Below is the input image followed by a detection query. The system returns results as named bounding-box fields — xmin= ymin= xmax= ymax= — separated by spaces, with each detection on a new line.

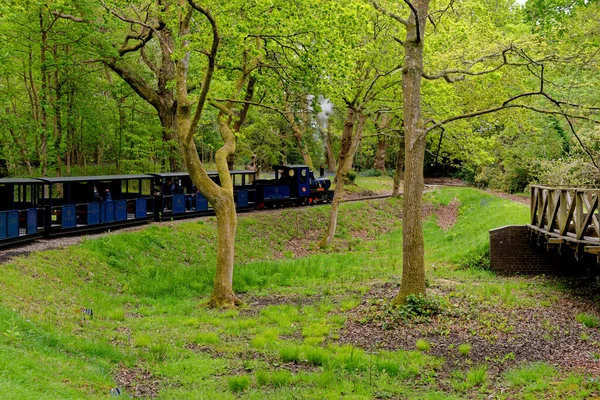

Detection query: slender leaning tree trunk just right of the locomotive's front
xmin=319 ymin=108 xmax=367 ymax=248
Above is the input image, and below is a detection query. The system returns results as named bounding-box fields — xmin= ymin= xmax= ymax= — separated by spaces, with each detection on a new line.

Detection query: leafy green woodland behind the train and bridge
xmin=0 ymin=0 xmax=600 ymax=192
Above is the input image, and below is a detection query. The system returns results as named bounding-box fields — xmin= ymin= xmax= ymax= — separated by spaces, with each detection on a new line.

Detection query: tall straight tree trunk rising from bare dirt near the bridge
xmin=394 ymin=0 xmax=429 ymax=304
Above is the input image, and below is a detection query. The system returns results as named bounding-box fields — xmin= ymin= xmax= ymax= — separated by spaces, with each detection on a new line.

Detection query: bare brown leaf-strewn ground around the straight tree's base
xmin=340 ymin=279 xmax=600 ymax=375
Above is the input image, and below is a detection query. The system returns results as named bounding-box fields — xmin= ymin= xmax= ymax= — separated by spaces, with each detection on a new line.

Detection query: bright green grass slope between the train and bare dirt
xmin=0 ymin=186 xmax=592 ymax=399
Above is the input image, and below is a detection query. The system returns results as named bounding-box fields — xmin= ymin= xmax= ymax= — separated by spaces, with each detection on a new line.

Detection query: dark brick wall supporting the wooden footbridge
xmin=489 ymin=225 xmax=595 ymax=275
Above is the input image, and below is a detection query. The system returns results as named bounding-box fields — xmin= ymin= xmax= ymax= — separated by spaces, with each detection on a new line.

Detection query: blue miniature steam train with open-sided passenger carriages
xmin=0 ymin=165 xmax=333 ymax=247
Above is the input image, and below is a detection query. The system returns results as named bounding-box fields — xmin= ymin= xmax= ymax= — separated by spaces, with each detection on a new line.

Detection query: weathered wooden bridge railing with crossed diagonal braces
xmin=528 ymin=185 xmax=600 ymax=247
